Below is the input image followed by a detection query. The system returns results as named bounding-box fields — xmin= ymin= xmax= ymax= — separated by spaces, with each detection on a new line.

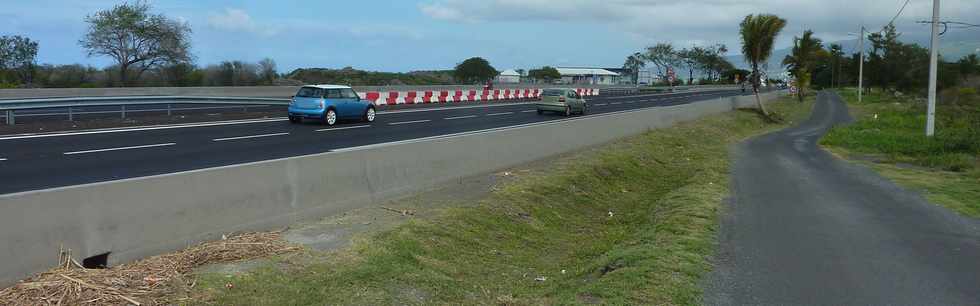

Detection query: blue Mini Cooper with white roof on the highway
xmin=289 ymin=85 xmax=376 ymax=125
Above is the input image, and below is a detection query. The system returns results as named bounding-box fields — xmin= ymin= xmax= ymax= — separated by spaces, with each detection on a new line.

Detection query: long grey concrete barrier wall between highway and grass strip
xmin=0 ymin=93 xmax=777 ymax=285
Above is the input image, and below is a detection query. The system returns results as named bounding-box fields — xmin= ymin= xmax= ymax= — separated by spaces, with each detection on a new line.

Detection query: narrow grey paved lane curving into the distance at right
xmin=705 ymin=92 xmax=980 ymax=305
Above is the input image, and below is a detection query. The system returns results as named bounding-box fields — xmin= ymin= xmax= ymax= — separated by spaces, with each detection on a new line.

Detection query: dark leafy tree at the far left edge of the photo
xmin=0 ymin=35 xmax=38 ymax=84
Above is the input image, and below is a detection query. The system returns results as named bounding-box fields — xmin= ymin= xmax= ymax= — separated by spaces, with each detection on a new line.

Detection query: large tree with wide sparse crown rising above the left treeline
xmin=78 ymin=2 xmax=191 ymax=86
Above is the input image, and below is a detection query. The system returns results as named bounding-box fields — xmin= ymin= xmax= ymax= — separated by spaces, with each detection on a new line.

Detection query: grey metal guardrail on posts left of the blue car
xmin=0 ymin=96 xmax=289 ymax=125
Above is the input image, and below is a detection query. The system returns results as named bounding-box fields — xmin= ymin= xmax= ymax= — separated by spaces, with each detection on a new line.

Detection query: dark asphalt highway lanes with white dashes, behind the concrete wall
xmin=0 ymin=90 xmax=742 ymax=194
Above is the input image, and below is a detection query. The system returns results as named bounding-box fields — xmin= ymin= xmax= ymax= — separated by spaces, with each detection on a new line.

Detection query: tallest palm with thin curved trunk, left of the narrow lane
xmin=739 ymin=14 xmax=786 ymax=116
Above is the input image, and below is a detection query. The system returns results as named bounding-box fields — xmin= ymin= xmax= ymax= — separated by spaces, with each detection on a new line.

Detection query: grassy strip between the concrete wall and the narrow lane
xmin=193 ymin=94 xmax=810 ymax=305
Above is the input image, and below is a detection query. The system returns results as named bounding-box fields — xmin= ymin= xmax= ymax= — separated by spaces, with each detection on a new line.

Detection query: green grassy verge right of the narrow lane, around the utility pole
xmin=821 ymin=89 xmax=980 ymax=218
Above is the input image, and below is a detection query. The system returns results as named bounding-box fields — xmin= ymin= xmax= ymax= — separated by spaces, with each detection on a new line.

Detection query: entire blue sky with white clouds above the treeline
xmin=0 ymin=0 xmax=980 ymax=71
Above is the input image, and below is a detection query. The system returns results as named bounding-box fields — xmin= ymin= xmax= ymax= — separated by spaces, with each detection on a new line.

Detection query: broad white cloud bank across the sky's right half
xmin=419 ymin=0 xmax=980 ymax=50
